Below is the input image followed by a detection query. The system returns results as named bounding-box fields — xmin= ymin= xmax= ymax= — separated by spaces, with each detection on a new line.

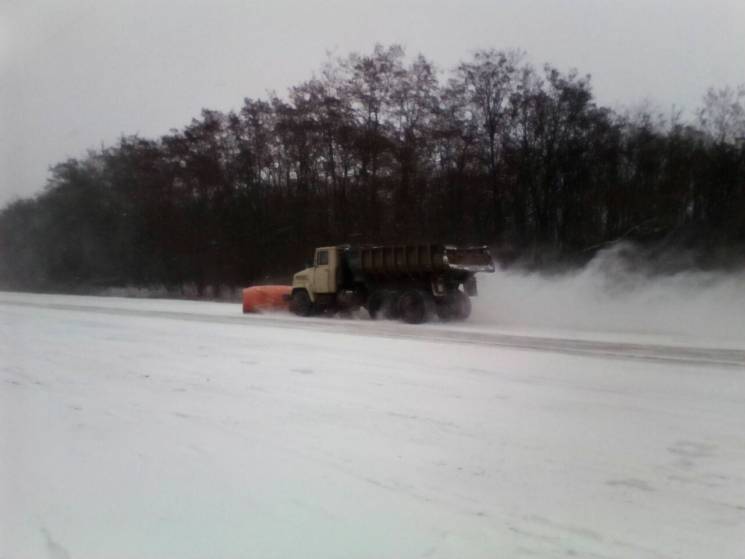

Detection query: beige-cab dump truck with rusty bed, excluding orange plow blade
xmin=289 ymin=244 xmax=494 ymax=324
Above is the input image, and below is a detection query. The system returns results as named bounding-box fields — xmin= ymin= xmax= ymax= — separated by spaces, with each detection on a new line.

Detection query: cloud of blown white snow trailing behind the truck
xmin=472 ymin=244 xmax=745 ymax=342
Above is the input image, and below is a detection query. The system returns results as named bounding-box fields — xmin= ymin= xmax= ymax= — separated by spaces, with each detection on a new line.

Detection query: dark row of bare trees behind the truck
xmin=0 ymin=45 xmax=745 ymax=292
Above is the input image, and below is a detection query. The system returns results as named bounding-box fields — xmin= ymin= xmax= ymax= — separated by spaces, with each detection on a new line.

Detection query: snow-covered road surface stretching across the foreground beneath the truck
xmin=0 ymin=294 xmax=745 ymax=559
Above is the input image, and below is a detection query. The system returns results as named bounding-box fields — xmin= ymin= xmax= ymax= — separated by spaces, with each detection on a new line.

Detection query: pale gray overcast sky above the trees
xmin=0 ymin=0 xmax=745 ymax=206
